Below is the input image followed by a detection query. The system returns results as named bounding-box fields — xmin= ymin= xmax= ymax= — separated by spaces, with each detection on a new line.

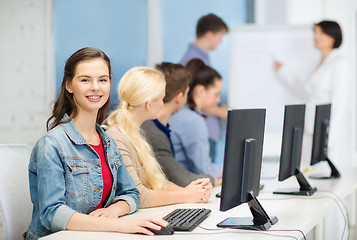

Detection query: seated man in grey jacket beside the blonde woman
xmin=141 ymin=62 xmax=221 ymax=187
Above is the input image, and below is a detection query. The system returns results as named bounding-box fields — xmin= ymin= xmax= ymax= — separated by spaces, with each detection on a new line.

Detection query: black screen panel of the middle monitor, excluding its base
xmin=279 ymin=105 xmax=305 ymax=181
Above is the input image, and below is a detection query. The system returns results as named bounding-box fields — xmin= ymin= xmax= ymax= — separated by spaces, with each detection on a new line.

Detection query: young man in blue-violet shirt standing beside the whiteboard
xmin=180 ymin=13 xmax=228 ymax=161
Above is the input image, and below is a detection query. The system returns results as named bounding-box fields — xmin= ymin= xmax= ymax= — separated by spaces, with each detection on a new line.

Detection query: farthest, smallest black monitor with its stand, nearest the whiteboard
xmin=309 ymin=104 xmax=341 ymax=179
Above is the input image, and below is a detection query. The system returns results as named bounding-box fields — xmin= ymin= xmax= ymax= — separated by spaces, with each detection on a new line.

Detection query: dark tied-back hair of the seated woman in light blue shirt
xmin=186 ymin=58 xmax=222 ymax=110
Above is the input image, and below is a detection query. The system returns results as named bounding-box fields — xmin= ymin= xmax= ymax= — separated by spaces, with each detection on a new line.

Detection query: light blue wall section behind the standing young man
xmin=161 ymin=0 xmax=247 ymax=102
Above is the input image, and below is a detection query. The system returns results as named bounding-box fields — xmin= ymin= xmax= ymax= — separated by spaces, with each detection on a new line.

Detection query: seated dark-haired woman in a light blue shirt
xmin=169 ymin=59 xmax=222 ymax=178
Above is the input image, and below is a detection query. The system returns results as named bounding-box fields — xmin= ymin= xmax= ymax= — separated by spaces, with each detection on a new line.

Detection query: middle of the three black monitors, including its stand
xmin=274 ymin=105 xmax=316 ymax=196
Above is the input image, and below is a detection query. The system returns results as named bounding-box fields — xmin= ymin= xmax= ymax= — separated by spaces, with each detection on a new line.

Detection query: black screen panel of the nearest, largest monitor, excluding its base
xmin=220 ymin=109 xmax=266 ymax=211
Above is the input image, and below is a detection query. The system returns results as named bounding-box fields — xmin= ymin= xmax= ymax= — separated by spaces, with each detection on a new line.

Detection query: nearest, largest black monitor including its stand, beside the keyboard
xmin=217 ymin=109 xmax=278 ymax=230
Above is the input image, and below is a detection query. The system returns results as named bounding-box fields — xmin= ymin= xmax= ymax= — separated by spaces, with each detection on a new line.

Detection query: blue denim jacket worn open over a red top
xmin=26 ymin=115 xmax=140 ymax=239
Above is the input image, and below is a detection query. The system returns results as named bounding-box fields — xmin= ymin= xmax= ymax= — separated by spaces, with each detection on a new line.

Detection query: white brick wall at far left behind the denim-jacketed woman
xmin=0 ymin=0 xmax=55 ymax=145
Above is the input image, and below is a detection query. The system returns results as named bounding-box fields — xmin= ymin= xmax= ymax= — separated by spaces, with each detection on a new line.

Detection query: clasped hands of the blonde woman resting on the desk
xmin=185 ymin=178 xmax=212 ymax=202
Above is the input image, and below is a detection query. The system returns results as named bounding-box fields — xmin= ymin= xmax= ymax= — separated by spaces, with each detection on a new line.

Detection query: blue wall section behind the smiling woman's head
xmin=54 ymin=0 xmax=147 ymax=108
